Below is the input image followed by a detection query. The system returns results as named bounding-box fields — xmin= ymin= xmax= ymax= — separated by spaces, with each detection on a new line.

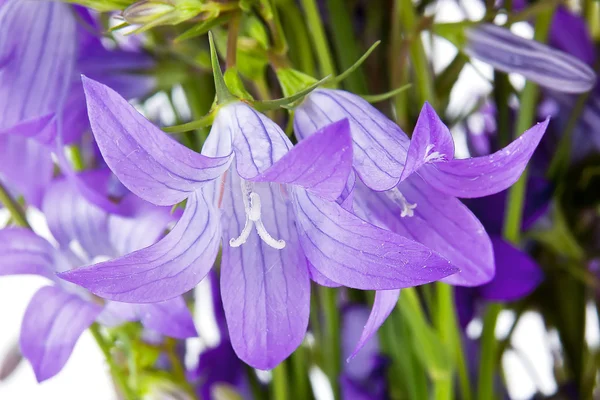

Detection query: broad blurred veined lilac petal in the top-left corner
xmin=0 ymin=0 xmax=76 ymax=141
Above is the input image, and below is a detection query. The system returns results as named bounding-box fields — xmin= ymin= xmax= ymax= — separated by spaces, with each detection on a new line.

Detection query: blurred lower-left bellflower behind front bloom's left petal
xmin=0 ymin=173 xmax=197 ymax=382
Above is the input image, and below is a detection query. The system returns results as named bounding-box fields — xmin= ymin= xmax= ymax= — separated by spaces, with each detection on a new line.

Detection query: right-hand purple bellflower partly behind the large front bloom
xmin=294 ymin=89 xmax=548 ymax=350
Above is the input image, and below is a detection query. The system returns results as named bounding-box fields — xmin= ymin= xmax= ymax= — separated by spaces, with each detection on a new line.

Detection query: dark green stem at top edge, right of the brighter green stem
xmin=327 ymin=0 xmax=368 ymax=93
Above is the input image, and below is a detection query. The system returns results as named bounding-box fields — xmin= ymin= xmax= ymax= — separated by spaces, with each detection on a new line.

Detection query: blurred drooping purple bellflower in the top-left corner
xmin=0 ymin=0 xmax=154 ymax=211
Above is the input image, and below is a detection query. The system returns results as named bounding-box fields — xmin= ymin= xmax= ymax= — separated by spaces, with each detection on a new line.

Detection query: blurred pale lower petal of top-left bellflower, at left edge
xmin=0 ymin=135 xmax=54 ymax=207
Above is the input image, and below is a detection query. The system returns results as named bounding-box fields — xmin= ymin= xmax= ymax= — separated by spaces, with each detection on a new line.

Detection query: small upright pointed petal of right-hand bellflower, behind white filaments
xmin=400 ymin=103 xmax=454 ymax=180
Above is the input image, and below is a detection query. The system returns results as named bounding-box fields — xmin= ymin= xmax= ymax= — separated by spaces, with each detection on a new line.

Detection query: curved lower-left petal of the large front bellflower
xmin=60 ymin=185 xmax=220 ymax=303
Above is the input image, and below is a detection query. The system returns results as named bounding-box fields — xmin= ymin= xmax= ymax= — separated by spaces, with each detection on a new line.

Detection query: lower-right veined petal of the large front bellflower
xmin=293 ymin=189 xmax=458 ymax=290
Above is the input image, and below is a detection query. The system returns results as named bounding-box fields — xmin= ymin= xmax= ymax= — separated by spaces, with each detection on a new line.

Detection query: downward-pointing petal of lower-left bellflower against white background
xmin=20 ymin=286 xmax=102 ymax=382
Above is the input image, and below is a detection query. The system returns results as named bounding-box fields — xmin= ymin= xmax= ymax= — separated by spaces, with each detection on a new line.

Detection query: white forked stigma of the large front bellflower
xmin=229 ymin=179 xmax=285 ymax=250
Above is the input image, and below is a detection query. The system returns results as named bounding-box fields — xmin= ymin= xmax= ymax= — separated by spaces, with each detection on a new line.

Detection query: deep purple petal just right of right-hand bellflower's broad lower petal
xmin=478 ymin=237 xmax=544 ymax=301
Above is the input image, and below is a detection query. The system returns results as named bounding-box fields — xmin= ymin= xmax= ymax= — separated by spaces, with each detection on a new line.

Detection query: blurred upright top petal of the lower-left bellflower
xmin=42 ymin=176 xmax=118 ymax=261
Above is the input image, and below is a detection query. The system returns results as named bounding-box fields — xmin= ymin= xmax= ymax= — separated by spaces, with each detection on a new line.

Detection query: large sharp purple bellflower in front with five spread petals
xmin=62 ymin=77 xmax=456 ymax=369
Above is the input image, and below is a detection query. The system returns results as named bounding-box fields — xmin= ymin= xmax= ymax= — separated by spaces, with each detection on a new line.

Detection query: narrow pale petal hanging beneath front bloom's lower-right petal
xmin=347 ymin=289 xmax=400 ymax=358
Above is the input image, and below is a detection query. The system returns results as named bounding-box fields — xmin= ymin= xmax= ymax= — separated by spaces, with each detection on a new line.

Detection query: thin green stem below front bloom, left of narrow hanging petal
xmin=319 ymin=286 xmax=342 ymax=399
